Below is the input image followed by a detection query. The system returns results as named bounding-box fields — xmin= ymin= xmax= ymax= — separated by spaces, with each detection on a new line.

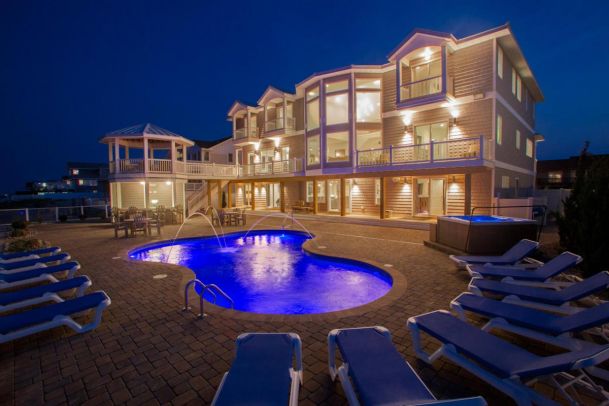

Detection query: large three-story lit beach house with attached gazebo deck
xmin=102 ymin=25 xmax=543 ymax=219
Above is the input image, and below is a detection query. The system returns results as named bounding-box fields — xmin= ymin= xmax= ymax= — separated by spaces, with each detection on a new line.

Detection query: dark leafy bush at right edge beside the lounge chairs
xmin=556 ymin=145 xmax=609 ymax=277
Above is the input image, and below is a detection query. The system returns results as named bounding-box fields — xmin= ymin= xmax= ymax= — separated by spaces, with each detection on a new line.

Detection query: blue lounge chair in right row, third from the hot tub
xmin=469 ymin=271 xmax=609 ymax=313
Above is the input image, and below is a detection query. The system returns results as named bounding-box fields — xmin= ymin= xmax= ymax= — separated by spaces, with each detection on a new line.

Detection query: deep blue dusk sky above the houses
xmin=0 ymin=0 xmax=609 ymax=192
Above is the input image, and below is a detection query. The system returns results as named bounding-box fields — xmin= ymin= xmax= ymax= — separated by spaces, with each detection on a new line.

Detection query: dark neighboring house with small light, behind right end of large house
xmin=537 ymin=154 xmax=609 ymax=189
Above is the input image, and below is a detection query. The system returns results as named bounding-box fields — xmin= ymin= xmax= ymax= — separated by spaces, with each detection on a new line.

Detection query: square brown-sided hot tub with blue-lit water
xmin=435 ymin=215 xmax=537 ymax=255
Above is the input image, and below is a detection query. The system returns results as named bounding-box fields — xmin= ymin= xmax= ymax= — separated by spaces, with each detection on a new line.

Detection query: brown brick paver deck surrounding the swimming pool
xmin=0 ymin=216 xmax=596 ymax=405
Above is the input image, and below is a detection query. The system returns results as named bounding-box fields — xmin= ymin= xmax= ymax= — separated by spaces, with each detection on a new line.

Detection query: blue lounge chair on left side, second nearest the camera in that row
xmin=0 ymin=276 xmax=91 ymax=312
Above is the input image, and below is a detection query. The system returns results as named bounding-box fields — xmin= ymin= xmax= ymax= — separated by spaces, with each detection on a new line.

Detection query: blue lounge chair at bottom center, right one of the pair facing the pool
xmin=328 ymin=326 xmax=486 ymax=406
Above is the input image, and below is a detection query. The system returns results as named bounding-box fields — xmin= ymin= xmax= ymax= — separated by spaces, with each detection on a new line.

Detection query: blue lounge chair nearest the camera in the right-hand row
xmin=408 ymin=310 xmax=609 ymax=405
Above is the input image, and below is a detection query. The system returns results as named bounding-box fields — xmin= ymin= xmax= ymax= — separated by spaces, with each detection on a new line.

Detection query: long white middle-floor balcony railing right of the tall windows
xmin=357 ymin=136 xmax=487 ymax=167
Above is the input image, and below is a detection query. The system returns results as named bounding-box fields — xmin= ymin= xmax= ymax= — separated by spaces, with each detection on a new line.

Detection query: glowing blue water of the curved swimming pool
xmin=129 ymin=231 xmax=392 ymax=314
